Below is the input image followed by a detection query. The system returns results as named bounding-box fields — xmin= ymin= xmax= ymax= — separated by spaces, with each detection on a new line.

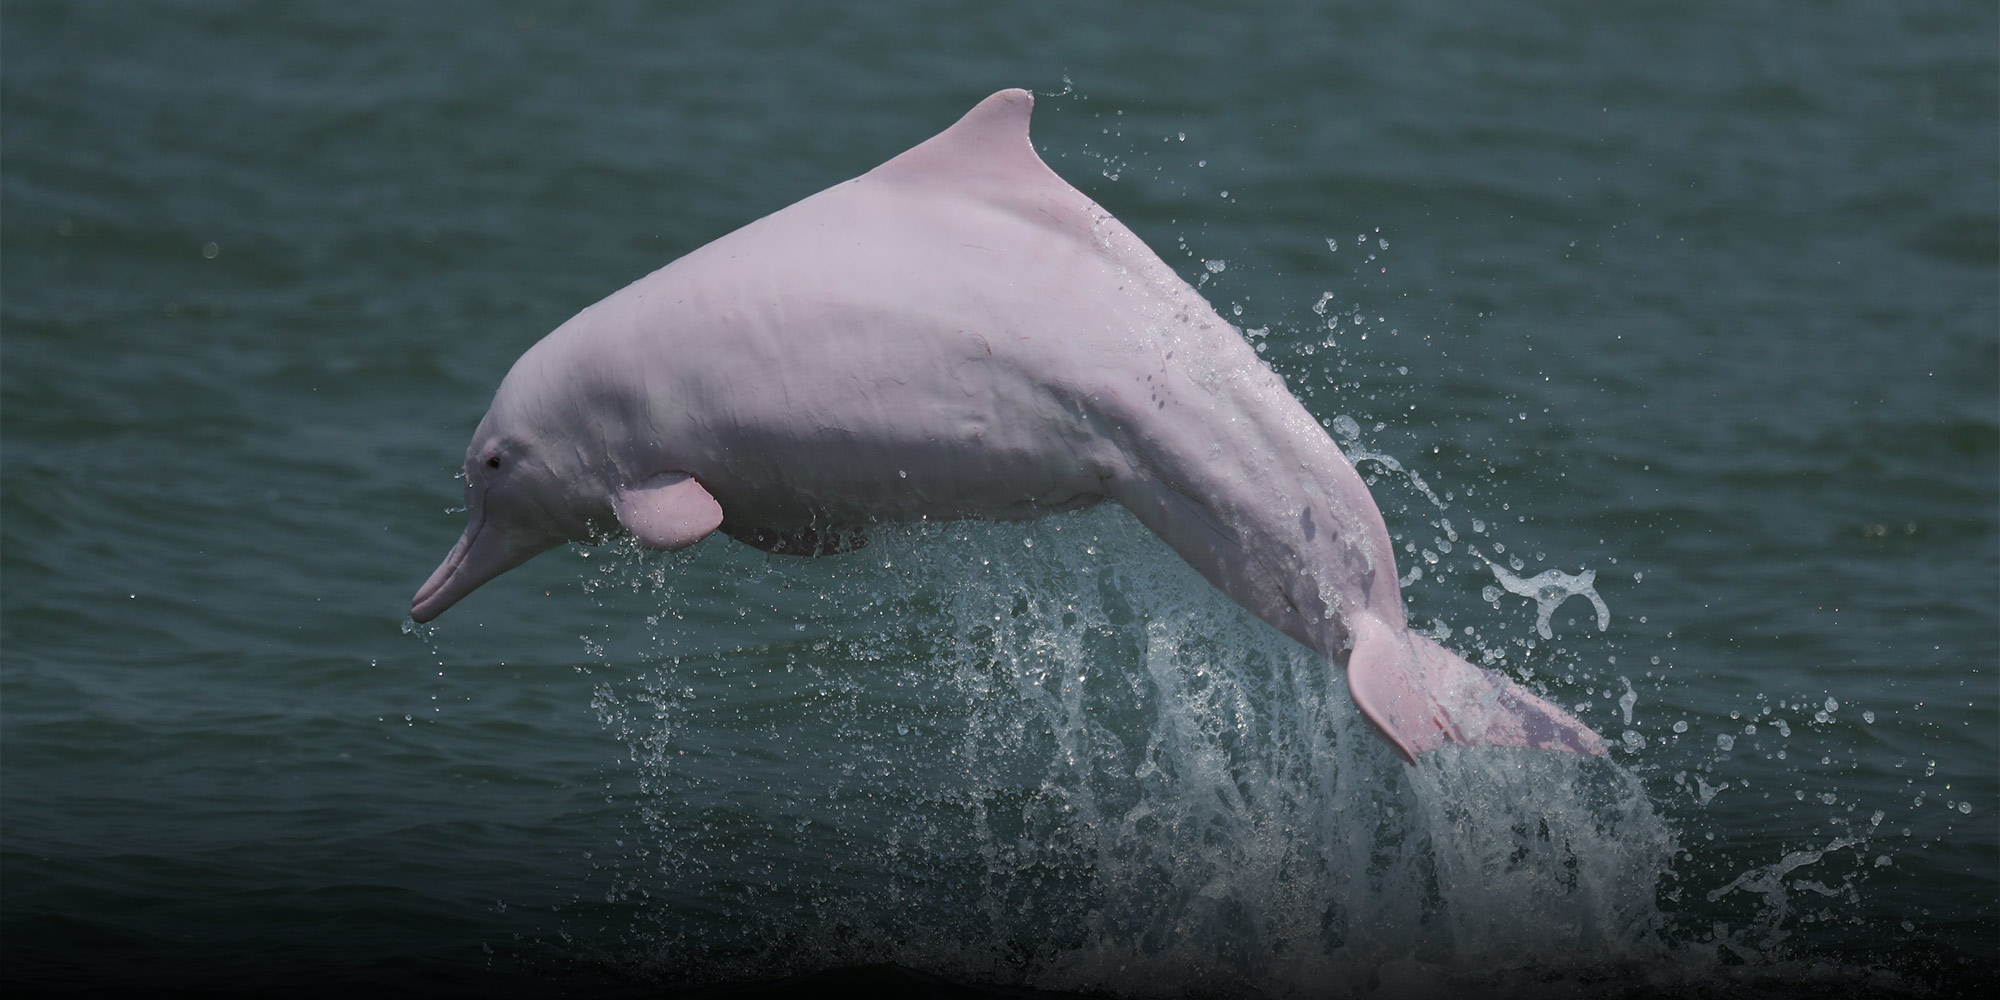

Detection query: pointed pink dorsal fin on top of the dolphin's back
xmin=866 ymin=88 xmax=1068 ymax=198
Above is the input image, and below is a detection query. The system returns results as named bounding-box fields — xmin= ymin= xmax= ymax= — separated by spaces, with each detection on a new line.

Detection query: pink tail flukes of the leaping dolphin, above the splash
xmin=1348 ymin=614 xmax=1604 ymax=764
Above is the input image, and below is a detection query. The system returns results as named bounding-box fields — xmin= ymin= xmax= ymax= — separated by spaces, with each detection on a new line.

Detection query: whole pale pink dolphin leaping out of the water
xmin=410 ymin=90 xmax=1604 ymax=762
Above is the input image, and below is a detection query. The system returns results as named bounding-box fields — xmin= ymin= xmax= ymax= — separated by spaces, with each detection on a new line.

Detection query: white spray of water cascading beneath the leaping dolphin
xmin=584 ymin=510 xmax=1676 ymax=996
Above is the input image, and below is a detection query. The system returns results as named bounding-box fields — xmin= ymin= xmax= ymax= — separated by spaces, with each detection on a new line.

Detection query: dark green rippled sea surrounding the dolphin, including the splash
xmin=0 ymin=0 xmax=2000 ymax=996
